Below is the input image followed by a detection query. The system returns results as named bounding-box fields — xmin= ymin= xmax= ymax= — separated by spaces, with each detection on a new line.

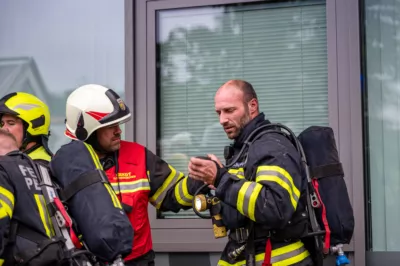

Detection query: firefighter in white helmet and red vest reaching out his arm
xmin=65 ymin=84 xmax=204 ymax=266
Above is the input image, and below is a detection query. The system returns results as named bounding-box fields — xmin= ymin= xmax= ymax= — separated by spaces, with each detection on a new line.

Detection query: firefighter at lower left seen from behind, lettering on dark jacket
xmin=0 ymin=129 xmax=62 ymax=266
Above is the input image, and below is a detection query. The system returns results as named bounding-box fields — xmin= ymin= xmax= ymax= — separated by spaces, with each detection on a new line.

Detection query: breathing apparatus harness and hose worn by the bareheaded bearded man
xmin=192 ymin=123 xmax=325 ymax=266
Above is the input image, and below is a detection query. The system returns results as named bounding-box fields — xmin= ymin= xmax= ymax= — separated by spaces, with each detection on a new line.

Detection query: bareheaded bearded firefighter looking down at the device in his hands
xmin=188 ymin=80 xmax=313 ymax=266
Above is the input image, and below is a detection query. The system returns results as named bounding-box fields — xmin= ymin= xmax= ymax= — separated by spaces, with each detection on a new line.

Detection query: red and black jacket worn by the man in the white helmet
xmin=101 ymin=141 xmax=203 ymax=261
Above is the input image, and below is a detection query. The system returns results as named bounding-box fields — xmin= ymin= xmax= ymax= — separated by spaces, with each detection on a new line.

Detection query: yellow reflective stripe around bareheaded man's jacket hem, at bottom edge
xmin=218 ymin=241 xmax=310 ymax=266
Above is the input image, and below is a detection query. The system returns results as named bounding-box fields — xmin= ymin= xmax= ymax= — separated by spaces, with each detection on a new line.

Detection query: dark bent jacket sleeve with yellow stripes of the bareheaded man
xmin=216 ymin=134 xmax=303 ymax=229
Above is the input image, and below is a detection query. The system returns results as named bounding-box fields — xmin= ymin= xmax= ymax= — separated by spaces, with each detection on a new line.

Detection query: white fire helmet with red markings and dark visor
xmin=65 ymin=84 xmax=131 ymax=141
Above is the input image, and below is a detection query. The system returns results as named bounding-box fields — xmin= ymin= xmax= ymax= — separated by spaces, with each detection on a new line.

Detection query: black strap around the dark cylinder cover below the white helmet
xmin=60 ymin=169 xmax=108 ymax=201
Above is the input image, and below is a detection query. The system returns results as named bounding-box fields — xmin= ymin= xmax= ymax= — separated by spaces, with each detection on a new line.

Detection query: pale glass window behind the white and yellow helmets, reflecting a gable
xmin=0 ymin=0 xmax=125 ymax=152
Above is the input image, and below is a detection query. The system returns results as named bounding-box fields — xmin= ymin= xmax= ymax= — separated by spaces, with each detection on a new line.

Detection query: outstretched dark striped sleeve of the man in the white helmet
xmin=146 ymin=149 xmax=209 ymax=212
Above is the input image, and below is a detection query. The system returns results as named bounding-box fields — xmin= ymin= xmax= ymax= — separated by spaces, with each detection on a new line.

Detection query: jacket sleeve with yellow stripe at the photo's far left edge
xmin=0 ymin=169 xmax=15 ymax=255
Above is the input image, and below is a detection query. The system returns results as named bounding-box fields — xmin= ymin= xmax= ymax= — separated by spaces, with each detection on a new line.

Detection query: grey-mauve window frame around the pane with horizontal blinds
xmin=125 ymin=0 xmax=365 ymax=265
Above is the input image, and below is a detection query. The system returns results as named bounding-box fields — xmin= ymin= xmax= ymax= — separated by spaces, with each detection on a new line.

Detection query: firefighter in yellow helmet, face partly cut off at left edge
xmin=0 ymin=92 xmax=53 ymax=165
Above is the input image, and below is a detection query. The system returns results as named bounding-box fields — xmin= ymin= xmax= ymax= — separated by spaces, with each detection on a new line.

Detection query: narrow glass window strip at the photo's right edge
xmin=364 ymin=0 xmax=400 ymax=251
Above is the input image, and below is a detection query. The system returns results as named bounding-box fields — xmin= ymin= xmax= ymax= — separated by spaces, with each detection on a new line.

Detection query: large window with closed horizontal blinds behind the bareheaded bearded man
xmin=157 ymin=0 xmax=328 ymax=217
